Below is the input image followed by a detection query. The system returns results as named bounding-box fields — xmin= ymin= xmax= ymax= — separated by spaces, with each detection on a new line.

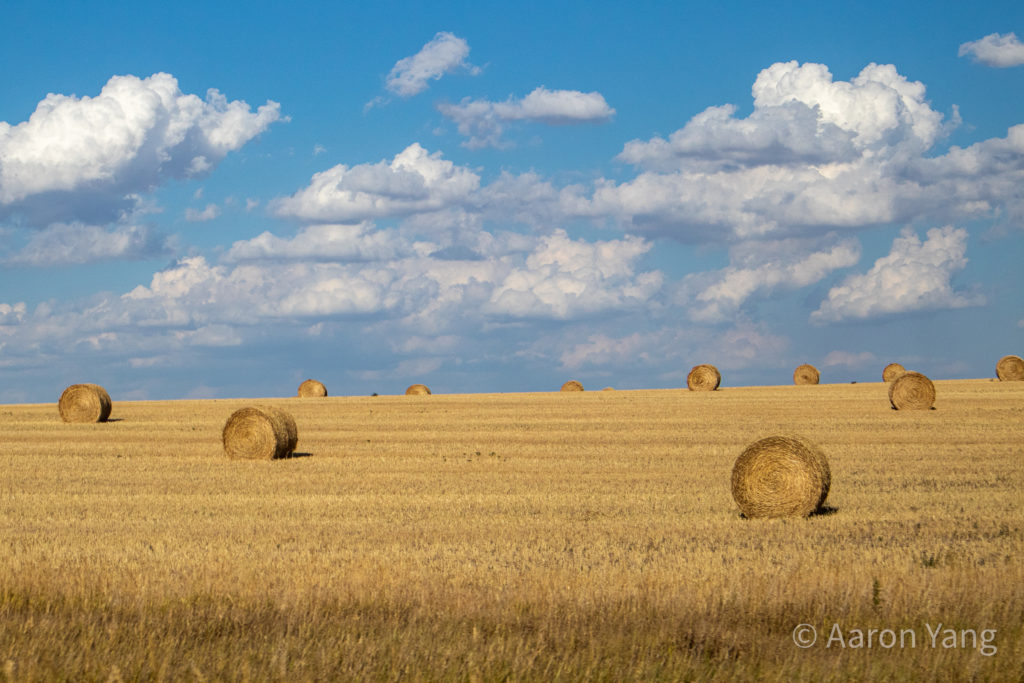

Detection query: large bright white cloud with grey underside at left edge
xmin=0 ymin=74 xmax=281 ymax=224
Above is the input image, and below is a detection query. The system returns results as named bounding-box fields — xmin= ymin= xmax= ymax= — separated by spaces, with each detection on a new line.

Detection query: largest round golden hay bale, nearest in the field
xmin=732 ymin=436 xmax=831 ymax=518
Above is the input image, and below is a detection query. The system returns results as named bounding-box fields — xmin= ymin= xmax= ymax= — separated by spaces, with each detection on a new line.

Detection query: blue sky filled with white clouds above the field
xmin=0 ymin=2 xmax=1024 ymax=402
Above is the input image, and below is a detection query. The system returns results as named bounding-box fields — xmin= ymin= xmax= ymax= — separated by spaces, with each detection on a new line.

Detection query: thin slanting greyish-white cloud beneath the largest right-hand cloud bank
xmin=682 ymin=236 xmax=860 ymax=323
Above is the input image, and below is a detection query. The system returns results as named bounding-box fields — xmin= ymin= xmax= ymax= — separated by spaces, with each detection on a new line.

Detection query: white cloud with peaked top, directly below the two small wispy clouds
xmin=271 ymin=142 xmax=480 ymax=223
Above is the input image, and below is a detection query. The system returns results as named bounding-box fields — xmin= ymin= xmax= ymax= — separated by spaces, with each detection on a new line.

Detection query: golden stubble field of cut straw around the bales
xmin=0 ymin=380 xmax=1024 ymax=681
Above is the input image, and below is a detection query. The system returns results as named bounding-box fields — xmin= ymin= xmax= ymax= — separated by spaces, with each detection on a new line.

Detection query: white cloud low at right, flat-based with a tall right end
xmin=811 ymin=226 xmax=984 ymax=323
